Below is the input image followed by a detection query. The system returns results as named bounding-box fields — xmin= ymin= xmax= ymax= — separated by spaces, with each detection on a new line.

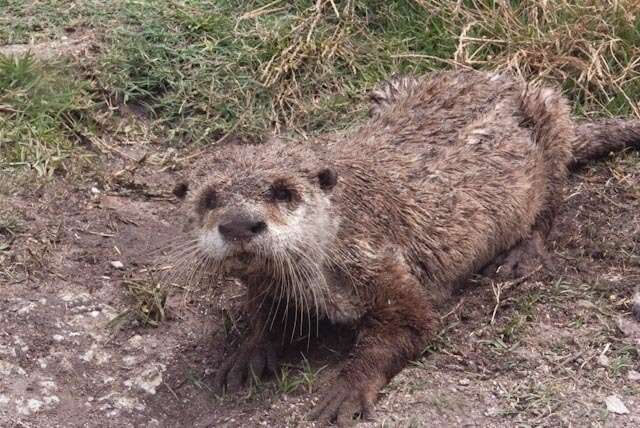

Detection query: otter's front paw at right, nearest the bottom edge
xmin=309 ymin=379 xmax=379 ymax=427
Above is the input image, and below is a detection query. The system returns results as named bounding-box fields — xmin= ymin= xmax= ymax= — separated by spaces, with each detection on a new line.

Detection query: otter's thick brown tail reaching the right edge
xmin=571 ymin=119 xmax=640 ymax=167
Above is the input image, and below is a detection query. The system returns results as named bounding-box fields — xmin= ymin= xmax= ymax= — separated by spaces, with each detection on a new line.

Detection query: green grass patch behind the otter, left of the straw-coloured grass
xmin=98 ymin=1 xmax=455 ymax=141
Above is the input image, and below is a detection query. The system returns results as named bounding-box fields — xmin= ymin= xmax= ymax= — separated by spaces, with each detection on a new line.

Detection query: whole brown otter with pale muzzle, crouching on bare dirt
xmin=179 ymin=71 xmax=640 ymax=425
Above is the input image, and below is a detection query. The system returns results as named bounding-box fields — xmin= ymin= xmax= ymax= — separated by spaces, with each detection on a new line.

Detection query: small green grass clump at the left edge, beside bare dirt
xmin=0 ymin=54 xmax=92 ymax=175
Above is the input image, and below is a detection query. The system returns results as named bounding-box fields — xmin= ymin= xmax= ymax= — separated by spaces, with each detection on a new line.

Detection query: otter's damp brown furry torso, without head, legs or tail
xmin=318 ymin=73 xmax=574 ymax=318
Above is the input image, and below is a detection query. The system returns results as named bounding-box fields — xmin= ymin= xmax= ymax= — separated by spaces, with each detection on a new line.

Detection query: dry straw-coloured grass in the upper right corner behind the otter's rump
xmin=420 ymin=0 xmax=640 ymax=117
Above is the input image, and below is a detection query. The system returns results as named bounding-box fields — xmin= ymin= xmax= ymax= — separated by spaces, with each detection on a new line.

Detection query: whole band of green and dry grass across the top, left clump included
xmin=0 ymin=0 xmax=640 ymax=174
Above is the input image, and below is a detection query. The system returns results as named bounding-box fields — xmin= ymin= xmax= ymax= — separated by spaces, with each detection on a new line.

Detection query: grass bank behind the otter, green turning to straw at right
xmin=94 ymin=0 xmax=640 ymax=142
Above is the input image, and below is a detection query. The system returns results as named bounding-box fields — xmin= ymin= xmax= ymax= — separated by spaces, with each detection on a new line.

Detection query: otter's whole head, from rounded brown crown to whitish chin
xmin=185 ymin=143 xmax=338 ymax=276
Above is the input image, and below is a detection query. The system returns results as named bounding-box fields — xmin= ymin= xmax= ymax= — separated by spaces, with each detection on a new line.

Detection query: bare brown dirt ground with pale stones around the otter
xmin=0 ymin=38 xmax=640 ymax=427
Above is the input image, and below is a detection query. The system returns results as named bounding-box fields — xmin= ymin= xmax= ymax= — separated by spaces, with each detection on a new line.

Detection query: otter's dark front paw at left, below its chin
xmin=215 ymin=341 xmax=278 ymax=391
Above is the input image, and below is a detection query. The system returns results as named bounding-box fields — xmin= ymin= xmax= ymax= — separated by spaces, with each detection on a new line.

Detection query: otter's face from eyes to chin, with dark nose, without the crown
xmin=194 ymin=168 xmax=337 ymax=274
